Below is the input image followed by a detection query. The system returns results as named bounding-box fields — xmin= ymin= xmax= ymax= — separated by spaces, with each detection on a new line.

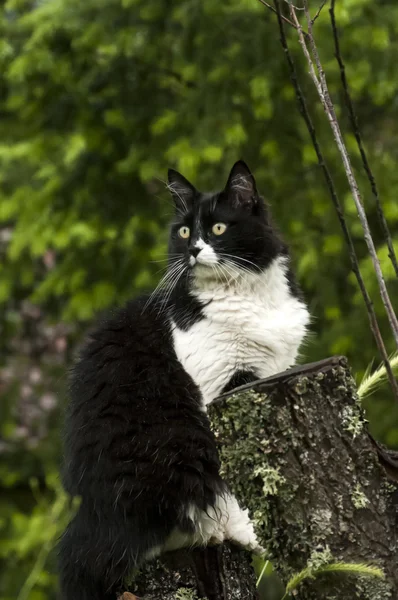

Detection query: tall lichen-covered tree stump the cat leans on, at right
xmin=209 ymin=357 xmax=398 ymax=600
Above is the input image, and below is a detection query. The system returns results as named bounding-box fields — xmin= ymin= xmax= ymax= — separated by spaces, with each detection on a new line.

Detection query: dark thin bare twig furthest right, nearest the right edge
xmin=329 ymin=0 xmax=398 ymax=277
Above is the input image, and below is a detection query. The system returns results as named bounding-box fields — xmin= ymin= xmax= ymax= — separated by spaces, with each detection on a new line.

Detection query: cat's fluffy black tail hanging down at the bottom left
xmin=58 ymin=510 xmax=145 ymax=600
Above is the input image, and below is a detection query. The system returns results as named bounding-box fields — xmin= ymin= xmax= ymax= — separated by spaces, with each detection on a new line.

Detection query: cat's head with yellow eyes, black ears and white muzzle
xmin=168 ymin=160 xmax=286 ymax=278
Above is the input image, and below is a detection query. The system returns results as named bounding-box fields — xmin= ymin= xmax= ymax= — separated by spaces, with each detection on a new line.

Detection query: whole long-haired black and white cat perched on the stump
xmin=60 ymin=161 xmax=309 ymax=600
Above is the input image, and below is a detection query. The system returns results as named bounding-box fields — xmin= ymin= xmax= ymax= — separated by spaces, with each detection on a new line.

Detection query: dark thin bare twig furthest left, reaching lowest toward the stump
xmin=274 ymin=0 xmax=398 ymax=402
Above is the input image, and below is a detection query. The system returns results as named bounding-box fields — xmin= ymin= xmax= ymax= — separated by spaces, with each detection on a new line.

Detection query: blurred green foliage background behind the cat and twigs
xmin=0 ymin=0 xmax=398 ymax=600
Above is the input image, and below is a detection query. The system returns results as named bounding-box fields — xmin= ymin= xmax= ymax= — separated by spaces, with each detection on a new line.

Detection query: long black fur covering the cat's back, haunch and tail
xmin=60 ymin=298 xmax=225 ymax=600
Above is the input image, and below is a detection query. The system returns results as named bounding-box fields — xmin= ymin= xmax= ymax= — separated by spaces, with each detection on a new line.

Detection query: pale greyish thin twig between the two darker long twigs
xmin=290 ymin=0 xmax=398 ymax=348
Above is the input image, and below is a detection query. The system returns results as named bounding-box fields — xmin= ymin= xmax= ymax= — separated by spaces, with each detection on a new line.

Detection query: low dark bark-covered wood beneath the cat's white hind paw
xmin=124 ymin=544 xmax=257 ymax=600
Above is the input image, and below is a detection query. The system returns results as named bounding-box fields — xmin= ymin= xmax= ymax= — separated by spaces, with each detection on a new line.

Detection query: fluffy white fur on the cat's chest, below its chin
xmin=173 ymin=258 xmax=309 ymax=404
